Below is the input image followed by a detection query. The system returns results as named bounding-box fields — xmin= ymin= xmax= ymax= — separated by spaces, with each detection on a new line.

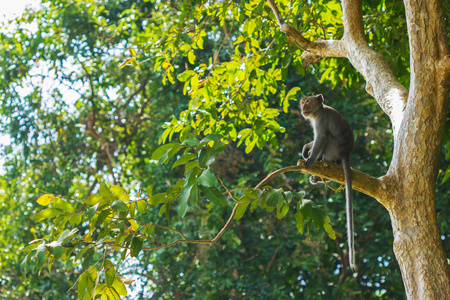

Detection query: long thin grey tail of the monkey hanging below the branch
xmin=342 ymin=157 xmax=357 ymax=272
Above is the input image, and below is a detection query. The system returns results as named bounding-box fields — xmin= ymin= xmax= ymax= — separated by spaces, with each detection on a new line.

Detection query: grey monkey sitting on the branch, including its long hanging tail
xmin=300 ymin=94 xmax=357 ymax=271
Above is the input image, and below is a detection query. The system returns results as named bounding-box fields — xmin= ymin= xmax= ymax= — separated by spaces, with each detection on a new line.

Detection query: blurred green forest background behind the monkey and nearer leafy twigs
xmin=0 ymin=0 xmax=450 ymax=299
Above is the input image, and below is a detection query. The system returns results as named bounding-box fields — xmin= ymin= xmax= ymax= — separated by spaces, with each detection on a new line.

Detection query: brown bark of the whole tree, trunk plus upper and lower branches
xmin=268 ymin=0 xmax=450 ymax=299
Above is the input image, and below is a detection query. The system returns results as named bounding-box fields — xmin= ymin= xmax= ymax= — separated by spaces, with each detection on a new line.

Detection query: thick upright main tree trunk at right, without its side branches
xmin=387 ymin=0 xmax=450 ymax=299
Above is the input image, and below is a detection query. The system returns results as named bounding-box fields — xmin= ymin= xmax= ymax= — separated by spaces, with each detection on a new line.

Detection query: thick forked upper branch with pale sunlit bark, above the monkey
xmin=267 ymin=0 xmax=408 ymax=138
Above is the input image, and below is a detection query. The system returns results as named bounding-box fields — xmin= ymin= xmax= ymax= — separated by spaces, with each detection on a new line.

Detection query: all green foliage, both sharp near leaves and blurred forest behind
xmin=0 ymin=0 xmax=450 ymax=299
